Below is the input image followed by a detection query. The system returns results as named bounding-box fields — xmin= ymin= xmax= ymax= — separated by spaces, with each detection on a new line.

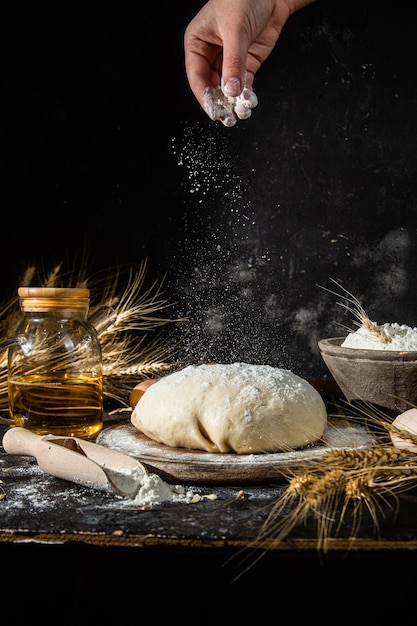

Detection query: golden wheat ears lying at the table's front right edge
xmin=231 ymin=403 xmax=417 ymax=578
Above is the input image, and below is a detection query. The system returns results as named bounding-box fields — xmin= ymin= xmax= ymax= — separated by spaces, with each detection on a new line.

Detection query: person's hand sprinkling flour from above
xmin=184 ymin=0 xmax=315 ymax=126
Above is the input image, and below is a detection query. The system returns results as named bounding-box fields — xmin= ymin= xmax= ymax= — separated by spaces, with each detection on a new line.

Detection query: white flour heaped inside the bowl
xmin=341 ymin=322 xmax=417 ymax=352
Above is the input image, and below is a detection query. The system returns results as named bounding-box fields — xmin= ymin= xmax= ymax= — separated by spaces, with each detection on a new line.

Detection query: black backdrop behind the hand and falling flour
xmin=0 ymin=0 xmax=417 ymax=378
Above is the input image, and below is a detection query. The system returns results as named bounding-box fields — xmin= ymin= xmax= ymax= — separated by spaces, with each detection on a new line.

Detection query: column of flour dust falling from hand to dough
xmin=173 ymin=124 xmax=292 ymax=368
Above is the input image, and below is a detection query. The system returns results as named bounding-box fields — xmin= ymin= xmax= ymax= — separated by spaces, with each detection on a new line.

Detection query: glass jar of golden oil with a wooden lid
xmin=8 ymin=287 xmax=103 ymax=439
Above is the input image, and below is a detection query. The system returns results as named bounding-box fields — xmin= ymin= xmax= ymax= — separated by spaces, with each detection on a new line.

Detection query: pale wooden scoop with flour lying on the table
xmin=2 ymin=426 xmax=147 ymax=498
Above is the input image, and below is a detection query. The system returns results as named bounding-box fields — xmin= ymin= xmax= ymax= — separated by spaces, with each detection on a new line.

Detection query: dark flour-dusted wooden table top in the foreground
xmin=0 ymin=390 xmax=417 ymax=551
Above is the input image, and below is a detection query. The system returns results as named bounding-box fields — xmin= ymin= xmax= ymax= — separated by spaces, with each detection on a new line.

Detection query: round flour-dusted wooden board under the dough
xmin=97 ymin=418 xmax=374 ymax=485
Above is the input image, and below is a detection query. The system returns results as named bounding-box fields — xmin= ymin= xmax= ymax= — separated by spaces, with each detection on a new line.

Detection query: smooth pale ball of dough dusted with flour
xmin=131 ymin=363 xmax=327 ymax=454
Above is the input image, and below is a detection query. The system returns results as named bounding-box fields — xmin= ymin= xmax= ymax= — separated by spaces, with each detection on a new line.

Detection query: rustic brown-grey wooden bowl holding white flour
xmin=318 ymin=337 xmax=417 ymax=414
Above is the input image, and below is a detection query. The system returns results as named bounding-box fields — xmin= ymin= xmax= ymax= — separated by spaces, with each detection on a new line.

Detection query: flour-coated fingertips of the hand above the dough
xmin=204 ymin=87 xmax=258 ymax=127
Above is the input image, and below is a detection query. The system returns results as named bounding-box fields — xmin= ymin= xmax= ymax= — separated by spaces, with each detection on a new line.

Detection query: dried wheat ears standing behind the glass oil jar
xmin=0 ymin=259 xmax=181 ymax=411
